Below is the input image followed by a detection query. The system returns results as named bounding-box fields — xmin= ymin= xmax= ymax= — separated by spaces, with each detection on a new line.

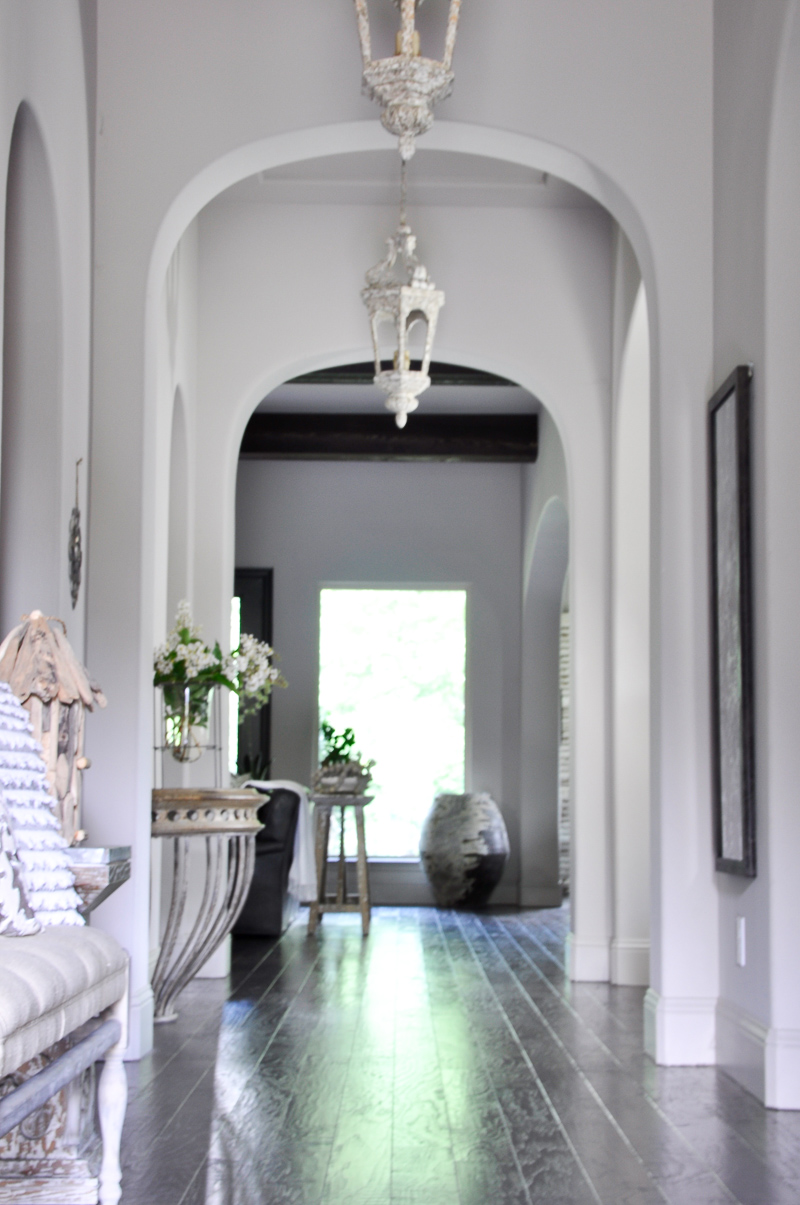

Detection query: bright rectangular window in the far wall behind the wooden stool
xmin=319 ymin=588 xmax=466 ymax=858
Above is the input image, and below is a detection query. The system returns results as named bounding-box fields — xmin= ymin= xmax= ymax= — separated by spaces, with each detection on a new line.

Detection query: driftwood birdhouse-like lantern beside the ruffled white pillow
xmin=0 ymin=611 xmax=106 ymax=845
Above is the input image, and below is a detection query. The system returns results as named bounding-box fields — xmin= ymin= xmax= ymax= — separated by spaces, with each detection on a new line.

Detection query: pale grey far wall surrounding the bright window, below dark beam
xmin=236 ymin=460 xmax=522 ymax=903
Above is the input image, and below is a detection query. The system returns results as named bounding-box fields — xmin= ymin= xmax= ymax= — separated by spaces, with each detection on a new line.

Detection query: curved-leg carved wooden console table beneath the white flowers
xmin=151 ymin=788 xmax=264 ymax=1022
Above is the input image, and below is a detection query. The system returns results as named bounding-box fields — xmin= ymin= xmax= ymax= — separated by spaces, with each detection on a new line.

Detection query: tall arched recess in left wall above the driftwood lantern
xmin=0 ymin=102 xmax=65 ymax=633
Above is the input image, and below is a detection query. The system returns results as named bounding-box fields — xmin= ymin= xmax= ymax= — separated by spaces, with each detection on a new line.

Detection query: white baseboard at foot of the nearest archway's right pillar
xmin=645 ymin=988 xmax=717 ymax=1066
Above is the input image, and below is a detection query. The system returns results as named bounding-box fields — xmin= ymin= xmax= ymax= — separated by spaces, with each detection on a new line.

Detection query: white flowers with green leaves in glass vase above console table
xmin=153 ymin=600 xmax=287 ymax=762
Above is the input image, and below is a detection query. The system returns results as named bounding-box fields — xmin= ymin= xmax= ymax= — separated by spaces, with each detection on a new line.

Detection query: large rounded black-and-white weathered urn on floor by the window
xmin=419 ymin=794 xmax=508 ymax=907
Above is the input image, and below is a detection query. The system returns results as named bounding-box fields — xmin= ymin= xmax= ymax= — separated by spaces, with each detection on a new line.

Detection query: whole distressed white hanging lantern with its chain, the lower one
xmin=361 ymin=159 xmax=445 ymax=427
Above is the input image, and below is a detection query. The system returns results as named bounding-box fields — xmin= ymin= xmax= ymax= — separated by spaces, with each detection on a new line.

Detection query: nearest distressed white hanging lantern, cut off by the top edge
xmin=354 ymin=0 xmax=461 ymax=159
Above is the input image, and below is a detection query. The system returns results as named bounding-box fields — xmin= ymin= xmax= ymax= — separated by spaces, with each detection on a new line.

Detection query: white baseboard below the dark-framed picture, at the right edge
xmin=717 ymin=1000 xmax=800 ymax=1109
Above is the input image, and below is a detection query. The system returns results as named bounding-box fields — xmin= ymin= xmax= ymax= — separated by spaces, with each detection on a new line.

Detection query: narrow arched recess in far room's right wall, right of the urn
xmin=519 ymin=484 xmax=570 ymax=907
